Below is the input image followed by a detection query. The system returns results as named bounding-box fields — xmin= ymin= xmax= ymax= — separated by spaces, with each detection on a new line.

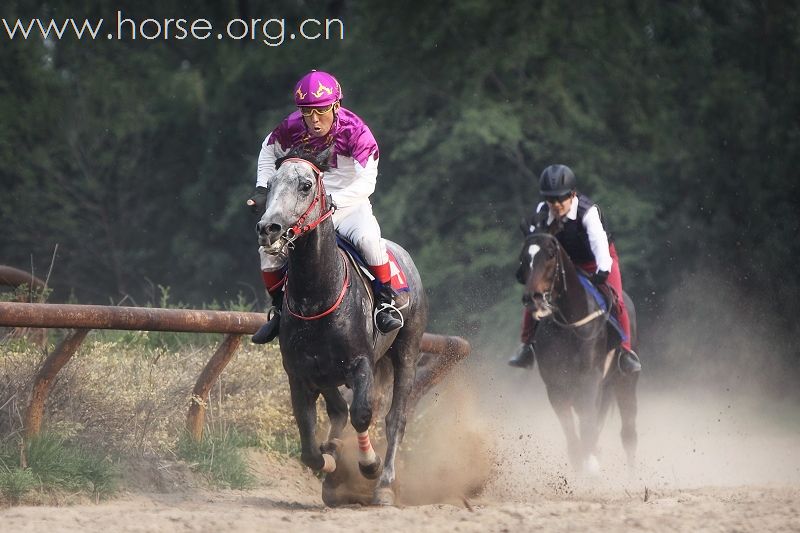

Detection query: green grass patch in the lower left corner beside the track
xmin=0 ymin=433 xmax=118 ymax=503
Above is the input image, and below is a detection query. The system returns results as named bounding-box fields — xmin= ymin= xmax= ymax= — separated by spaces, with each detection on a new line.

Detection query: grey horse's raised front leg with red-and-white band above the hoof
xmin=350 ymin=356 xmax=381 ymax=479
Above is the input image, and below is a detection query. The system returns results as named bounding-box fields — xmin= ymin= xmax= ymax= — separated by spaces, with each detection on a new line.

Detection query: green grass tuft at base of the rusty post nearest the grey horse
xmin=177 ymin=429 xmax=257 ymax=489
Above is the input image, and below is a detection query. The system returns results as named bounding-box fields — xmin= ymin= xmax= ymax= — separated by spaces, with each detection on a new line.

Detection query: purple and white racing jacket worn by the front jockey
xmin=256 ymin=107 xmax=378 ymax=208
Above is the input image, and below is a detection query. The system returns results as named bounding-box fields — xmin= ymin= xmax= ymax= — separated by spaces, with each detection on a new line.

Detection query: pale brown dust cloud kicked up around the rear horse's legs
xmin=403 ymin=270 xmax=800 ymax=503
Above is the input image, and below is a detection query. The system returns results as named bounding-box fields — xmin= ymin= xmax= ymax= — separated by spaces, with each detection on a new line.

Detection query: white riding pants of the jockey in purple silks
xmin=258 ymin=202 xmax=389 ymax=272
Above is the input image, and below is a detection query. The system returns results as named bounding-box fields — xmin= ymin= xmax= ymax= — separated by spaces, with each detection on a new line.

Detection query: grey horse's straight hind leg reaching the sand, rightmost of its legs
xmin=372 ymin=345 xmax=416 ymax=505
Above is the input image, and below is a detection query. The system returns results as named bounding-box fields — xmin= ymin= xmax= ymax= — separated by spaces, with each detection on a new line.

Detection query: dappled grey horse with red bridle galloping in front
xmin=256 ymin=151 xmax=428 ymax=505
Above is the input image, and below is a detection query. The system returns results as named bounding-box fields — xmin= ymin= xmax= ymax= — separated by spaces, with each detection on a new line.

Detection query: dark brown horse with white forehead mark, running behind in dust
xmin=520 ymin=229 xmax=638 ymax=474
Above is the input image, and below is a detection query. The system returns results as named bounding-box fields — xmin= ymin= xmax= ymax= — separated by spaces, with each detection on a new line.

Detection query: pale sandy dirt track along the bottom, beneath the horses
xmin=0 ymin=487 xmax=800 ymax=533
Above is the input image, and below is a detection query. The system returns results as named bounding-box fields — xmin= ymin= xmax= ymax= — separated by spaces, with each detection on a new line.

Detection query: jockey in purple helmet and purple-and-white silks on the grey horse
xmin=247 ymin=70 xmax=402 ymax=344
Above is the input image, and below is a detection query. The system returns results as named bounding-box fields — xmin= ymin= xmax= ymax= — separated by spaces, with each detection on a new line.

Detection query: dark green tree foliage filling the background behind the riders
xmin=0 ymin=0 xmax=800 ymax=358
